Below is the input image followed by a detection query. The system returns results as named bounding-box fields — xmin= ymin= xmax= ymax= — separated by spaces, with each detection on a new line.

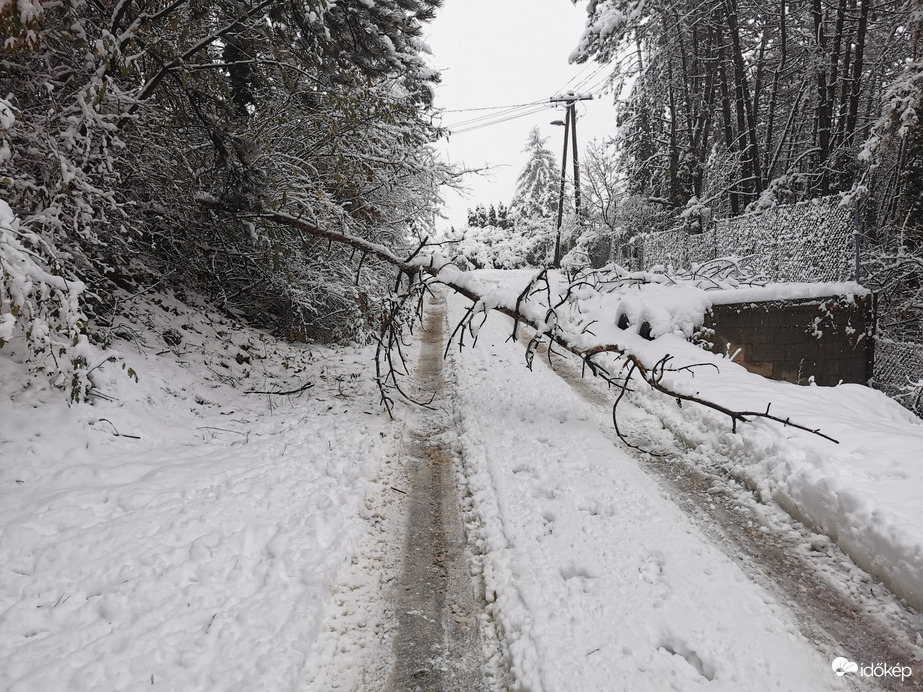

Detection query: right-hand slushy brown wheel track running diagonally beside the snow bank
xmin=520 ymin=333 xmax=923 ymax=692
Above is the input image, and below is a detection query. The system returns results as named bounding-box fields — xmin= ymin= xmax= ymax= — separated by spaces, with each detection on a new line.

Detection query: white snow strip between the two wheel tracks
xmin=449 ymin=290 xmax=841 ymax=692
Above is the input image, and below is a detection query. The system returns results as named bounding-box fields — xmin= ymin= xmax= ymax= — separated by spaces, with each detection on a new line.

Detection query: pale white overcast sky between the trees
xmin=426 ymin=0 xmax=615 ymax=228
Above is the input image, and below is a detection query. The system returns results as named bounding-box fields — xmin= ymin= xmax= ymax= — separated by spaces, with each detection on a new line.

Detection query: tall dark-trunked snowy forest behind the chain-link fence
xmin=575 ymin=0 xmax=920 ymax=216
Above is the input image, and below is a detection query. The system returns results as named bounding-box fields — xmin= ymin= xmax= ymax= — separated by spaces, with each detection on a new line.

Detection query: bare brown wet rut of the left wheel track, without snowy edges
xmin=385 ymin=295 xmax=498 ymax=692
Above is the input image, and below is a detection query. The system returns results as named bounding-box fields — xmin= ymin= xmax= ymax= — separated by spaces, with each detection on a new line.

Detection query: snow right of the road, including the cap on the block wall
xmin=462 ymin=272 xmax=923 ymax=611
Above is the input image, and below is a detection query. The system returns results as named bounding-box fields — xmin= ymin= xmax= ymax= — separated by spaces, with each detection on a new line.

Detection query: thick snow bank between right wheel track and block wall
xmin=638 ymin=363 xmax=923 ymax=610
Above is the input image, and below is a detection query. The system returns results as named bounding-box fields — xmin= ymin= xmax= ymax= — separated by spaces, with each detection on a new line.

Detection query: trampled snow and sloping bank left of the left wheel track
xmin=0 ymin=297 xmax=396 ymax=692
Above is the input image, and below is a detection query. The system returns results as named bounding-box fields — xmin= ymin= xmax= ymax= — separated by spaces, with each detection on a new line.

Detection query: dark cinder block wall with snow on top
xmin=699 ymin=295 xmax=875 ymax=386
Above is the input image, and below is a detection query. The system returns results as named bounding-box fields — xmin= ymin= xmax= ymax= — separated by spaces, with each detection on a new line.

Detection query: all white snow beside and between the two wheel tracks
xmin=0 ymin=272 xmax=923 ymax=692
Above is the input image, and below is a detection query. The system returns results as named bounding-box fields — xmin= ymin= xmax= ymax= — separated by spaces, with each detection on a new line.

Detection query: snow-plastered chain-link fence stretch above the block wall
xmin=630 ymin=196 xmax=855 ymax=281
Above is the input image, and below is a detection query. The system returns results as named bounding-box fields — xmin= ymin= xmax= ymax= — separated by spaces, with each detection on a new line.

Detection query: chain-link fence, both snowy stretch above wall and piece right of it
xmin=620 ymin=196 xmax=923 ymax=417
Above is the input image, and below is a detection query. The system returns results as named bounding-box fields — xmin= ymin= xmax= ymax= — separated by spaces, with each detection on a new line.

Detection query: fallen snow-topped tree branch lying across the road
xmin=260 ymin=212 xmax=838 ymax=447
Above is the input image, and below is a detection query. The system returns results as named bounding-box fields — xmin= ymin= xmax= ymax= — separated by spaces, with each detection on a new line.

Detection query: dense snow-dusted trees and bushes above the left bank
xmin=0 ymin=0 xmax=444 ymax=340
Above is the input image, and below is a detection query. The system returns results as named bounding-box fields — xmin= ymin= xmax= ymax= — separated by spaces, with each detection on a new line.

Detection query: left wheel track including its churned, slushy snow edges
xmin=300 ymin=297 xmax=508 ymax=692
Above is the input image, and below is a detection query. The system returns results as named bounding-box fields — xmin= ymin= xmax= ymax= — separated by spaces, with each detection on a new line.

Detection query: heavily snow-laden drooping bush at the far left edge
xmin=0 ymin=200 xmax=92 ymax=402
